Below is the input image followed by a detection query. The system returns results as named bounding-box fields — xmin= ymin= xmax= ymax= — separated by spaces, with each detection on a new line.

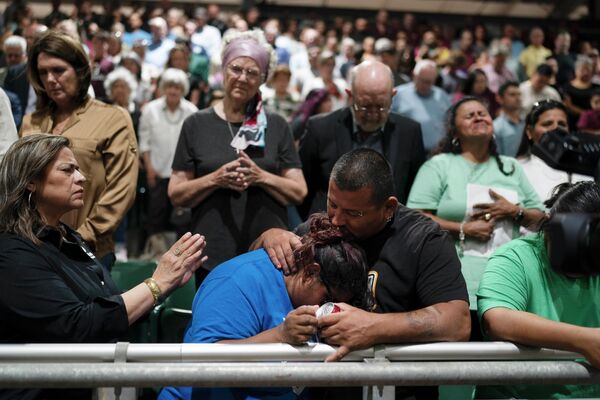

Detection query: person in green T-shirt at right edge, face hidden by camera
xmin=477 ymin=182 xmax=600 ymax=399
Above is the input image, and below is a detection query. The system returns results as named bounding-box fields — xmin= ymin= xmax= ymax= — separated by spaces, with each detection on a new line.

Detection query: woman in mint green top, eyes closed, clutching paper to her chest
xmin=407 ymin=97 xmax=544 ymax=309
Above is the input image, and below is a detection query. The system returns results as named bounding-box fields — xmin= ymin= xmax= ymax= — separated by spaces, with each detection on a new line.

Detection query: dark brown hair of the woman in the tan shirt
xmin=27 ymin=30 xmax=92 ymax=115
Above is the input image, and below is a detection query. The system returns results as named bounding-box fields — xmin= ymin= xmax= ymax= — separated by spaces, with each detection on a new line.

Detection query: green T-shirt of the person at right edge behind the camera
xmin=477 ymin=234 xmax=600 ymax=398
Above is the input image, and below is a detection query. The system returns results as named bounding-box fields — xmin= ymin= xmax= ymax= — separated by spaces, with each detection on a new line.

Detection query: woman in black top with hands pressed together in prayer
xmin=0 ymin=134 xmax=205 ymax=399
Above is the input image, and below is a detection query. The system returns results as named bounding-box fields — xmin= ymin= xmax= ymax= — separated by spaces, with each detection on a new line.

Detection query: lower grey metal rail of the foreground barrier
xmin=0 ymin=361 xmax=600 ymax=388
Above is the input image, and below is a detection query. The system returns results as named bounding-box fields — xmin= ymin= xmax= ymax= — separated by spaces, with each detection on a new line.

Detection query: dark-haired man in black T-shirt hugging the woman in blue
xmin=253 ymin=149 xmax=471 ymax=398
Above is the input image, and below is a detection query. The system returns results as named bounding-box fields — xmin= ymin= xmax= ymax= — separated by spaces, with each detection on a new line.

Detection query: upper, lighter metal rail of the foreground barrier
xmin=0 ymin=342 xmax=583 ymax=363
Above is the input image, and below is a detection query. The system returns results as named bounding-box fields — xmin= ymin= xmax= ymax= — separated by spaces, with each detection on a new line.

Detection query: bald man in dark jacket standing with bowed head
xmin=299 ymin=61 xmax=425 ymax=218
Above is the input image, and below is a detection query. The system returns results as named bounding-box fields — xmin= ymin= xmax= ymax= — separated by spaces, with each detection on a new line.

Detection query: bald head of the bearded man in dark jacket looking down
xmin=348 ymin=60 xmax=395 ymax=133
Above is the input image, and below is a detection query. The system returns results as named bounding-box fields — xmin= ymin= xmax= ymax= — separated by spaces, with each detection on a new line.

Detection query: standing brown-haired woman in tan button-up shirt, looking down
xmin=21 ymin=31 xmax=138 ymax=268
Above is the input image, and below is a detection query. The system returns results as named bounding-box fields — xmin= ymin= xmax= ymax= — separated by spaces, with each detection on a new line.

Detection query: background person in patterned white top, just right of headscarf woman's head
xmin=261 ymin=64 xmax=300 ymax=122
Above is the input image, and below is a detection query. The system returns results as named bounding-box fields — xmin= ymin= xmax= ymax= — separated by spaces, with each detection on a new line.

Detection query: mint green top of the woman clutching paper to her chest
xmin=407 ymin=153 xmax=544 ymax=310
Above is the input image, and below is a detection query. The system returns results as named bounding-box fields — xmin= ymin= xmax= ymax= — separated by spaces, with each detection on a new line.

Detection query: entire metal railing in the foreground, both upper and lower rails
xmin=0 ymin=342 xmax=600 ymax=388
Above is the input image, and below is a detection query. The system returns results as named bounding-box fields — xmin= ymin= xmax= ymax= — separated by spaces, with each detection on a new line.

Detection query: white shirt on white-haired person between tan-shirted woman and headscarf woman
xmin=138 ymin=97 xmax=198 ymax=178
